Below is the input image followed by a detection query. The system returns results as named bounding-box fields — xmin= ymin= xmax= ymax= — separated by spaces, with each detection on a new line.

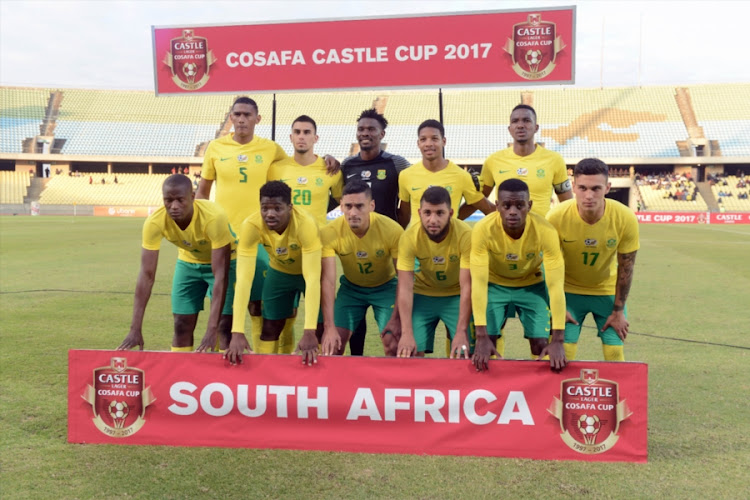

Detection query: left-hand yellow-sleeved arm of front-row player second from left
xmin=224 ymin=226 xmax=260 ymax=364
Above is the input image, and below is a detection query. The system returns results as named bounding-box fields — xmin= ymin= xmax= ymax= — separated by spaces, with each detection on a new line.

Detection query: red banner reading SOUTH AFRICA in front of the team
xmin=68 ymin=350 xmax=648 ymax=462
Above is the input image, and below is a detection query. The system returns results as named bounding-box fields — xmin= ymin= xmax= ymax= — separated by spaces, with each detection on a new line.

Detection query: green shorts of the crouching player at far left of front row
xmin=172 ymin=259 xmax=237 ymax=316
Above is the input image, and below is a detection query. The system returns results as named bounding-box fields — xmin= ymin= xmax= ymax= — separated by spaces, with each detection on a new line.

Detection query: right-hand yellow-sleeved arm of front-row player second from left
xmin=297 ymin=247 xmax=322 ymax=365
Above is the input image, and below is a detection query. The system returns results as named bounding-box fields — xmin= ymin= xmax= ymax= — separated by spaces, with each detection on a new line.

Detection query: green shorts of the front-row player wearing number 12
xmin=334 ymin=275 xmax=397 ymax=332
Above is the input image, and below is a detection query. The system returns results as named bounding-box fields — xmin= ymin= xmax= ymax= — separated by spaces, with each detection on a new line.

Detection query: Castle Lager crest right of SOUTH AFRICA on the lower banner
xmin=547 ymin=368 xmax=632 ymax=454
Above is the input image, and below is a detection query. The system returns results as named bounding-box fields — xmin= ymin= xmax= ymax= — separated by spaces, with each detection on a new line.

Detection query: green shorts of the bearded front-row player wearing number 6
xmin=411 ymin=293 xmax=476 ymax=353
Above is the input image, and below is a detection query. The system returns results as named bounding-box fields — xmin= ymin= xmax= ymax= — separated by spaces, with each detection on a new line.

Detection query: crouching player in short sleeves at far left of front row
xmin=118 ymin=174 xmax=237 ymax=352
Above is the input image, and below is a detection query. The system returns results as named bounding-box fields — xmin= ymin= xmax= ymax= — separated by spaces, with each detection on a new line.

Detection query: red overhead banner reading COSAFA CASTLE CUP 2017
xmin=152 ymin=7 xmax=575 ymax=94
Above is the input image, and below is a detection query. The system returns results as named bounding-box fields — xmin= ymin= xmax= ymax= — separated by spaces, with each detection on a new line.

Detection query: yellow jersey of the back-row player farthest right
xmin=479 ymin=145 xmax=568 ymax=217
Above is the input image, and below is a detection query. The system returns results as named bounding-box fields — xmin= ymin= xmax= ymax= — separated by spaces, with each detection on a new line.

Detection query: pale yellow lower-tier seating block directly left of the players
xmin=39 ymin=174 xmax=168 ymax=206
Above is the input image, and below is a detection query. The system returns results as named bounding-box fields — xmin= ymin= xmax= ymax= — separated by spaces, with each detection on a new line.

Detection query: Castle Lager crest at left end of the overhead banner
xmin=164 ymin=30 xmax=216 ymax=90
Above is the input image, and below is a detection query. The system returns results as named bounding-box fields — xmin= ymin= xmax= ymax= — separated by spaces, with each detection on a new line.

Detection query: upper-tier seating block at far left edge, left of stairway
xmin=0 ymin=87 xmax=49 ymax=153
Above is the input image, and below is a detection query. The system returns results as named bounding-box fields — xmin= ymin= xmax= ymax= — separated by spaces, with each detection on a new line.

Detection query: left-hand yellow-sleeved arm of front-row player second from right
xmin=470 ymin=227 xmax=500 ymax=371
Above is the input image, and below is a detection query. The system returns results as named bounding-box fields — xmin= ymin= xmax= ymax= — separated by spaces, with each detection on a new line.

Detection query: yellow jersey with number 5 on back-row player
xmin=201 ymin=133 xmax=287 ymax=229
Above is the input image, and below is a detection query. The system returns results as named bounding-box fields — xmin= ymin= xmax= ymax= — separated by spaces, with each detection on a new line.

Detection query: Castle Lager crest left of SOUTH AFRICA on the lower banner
xmin=81 ymin=358 xmax=156 ymax=438
